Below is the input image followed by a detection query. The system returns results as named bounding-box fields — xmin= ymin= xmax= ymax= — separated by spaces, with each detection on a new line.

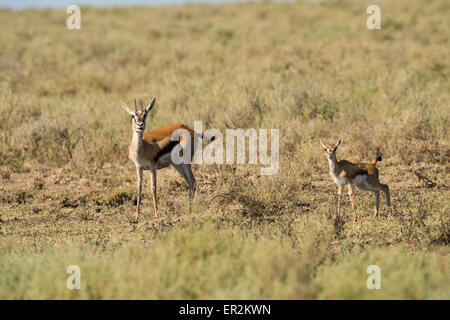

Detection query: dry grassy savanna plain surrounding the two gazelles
xmin=0 ymin=0 xmax=450 ymax=299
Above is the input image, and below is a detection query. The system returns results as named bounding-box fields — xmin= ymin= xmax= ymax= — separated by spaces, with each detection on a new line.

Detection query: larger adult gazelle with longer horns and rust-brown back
xmin=120 ymin=98 xmax=214 ymax=219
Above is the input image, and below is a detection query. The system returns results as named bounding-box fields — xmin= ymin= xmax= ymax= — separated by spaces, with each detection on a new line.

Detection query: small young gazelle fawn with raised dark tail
xmin=320 ymin=139 xmax=391 ymax=221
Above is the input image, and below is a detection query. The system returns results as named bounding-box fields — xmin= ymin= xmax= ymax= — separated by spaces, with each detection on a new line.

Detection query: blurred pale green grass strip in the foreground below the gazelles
xmin=0 ymin=223 xmax=450 ymax=299
